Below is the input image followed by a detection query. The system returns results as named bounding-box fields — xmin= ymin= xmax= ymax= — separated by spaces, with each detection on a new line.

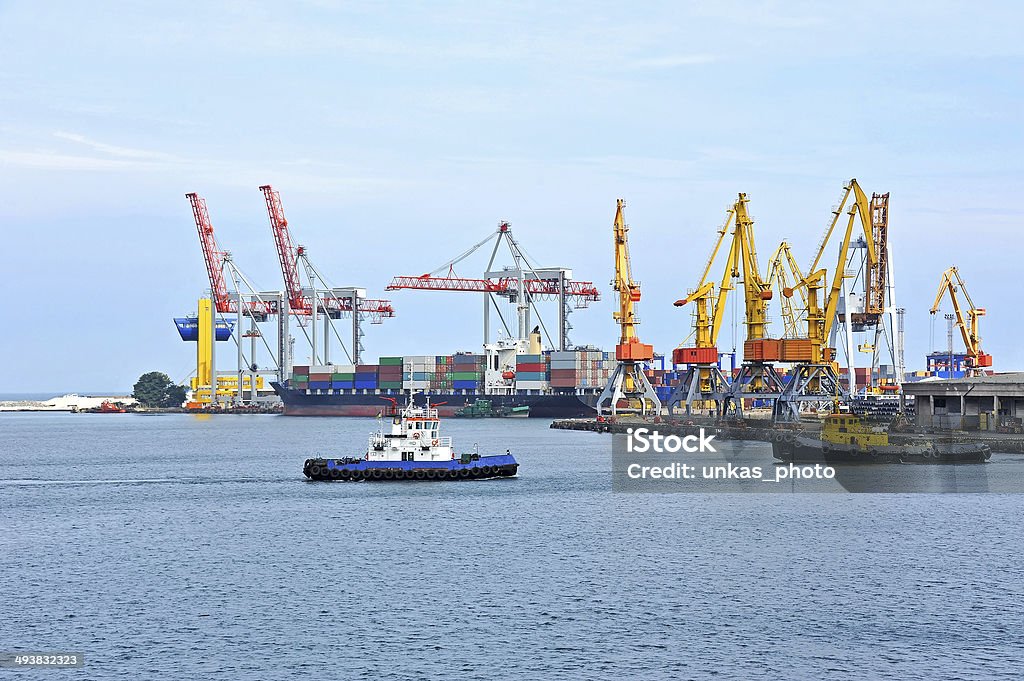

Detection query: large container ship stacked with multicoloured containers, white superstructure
xmin=272 ymin=341 xmax=615 ymax=419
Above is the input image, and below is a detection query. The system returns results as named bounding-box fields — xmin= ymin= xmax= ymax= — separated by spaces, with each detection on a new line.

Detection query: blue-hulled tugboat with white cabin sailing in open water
xmin=302 ymin=397 xmax=519 ymax=481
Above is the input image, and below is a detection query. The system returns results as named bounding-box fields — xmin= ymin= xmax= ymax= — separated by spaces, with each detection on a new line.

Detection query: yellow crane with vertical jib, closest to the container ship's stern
xmin=597 ymin=199 xmax=662 ymax=416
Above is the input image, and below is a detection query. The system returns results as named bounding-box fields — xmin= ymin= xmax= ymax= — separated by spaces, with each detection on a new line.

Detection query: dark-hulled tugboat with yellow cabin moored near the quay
xmin=772 ymin=412 xmax=992 ymax=464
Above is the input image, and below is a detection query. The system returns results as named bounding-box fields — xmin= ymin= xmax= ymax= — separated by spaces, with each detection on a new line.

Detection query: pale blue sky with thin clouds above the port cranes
xmin=0 ymin=0 xmax=1024 ymax=392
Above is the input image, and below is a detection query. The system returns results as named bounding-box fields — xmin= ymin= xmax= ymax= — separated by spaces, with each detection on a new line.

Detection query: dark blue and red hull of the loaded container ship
xmin=271 ymin=383 xmax=597 ymax=419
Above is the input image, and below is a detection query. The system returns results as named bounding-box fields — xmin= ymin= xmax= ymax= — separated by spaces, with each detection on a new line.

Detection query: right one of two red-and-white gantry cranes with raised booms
xmin=259 ymin=184 xmax=394 ymax=365
